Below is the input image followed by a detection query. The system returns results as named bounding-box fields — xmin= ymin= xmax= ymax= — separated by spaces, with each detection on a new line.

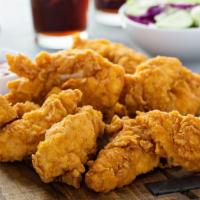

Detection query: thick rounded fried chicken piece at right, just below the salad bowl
xmin=120 ymin=57 xmax=200 ymax=114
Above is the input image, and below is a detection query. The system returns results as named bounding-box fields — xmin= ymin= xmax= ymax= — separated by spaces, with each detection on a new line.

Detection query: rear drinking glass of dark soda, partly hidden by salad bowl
xmin=95 ymin=0 xmax=126 ymax=26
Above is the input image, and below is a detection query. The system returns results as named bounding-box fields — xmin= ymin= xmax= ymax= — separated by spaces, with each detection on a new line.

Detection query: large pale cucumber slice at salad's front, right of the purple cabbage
xmin=155 ymin=10 xmax=194 ymax=29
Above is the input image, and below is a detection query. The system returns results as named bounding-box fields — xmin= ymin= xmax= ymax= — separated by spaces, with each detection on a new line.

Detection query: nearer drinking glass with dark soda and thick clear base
xmin=31 ymin=0 xmax=88 ymax=49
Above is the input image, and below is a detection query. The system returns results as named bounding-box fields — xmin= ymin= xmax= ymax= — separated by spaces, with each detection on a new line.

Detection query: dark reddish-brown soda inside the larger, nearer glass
xmin=31 ymin=0 xmax=88 ymax=36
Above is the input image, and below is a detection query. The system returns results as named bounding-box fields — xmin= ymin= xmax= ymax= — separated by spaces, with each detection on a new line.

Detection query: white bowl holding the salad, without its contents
xmin=119 ymin=5 xmax=200 ymax=61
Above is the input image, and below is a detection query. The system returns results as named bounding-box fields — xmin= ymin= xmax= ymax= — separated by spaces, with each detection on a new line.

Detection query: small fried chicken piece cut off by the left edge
xmin=0 ymin=95 xmax=17 ymax=127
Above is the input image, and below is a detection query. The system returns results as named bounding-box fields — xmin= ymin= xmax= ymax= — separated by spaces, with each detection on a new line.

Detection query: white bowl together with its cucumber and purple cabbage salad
xmin=119 ymin=0 xmax=200 ymax=60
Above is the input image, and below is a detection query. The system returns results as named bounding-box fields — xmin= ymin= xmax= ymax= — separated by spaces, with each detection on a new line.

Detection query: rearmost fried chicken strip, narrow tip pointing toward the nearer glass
xmin=73 ymin=36 xmax=147 ymax=74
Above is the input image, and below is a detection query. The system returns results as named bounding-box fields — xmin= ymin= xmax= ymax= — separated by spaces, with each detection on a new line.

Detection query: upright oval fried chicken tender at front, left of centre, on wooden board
xmin=32 ymin=106 xmax=104 ymax=188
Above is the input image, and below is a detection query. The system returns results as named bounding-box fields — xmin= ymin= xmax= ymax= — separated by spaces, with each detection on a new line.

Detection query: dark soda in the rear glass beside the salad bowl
xmin=95 ymin=0 xmax=126 ymax=13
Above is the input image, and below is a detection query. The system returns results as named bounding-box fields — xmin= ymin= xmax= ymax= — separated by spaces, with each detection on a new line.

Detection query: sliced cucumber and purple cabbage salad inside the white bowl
xmin=125 ymin=0 xmax=200 ymax=29
